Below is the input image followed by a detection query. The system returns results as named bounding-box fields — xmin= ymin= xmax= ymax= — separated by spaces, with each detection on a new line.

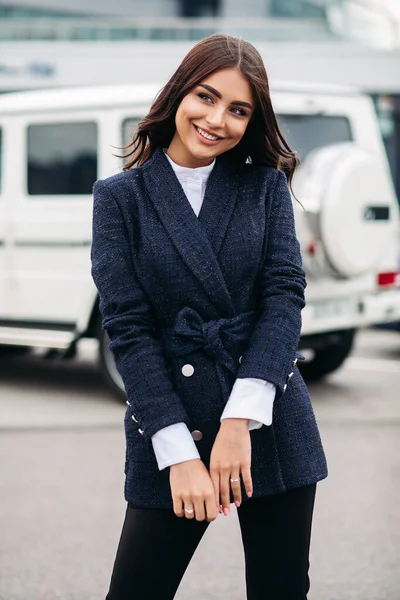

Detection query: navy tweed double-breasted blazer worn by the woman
xmin=91 ymin=149 xmax=327 ymax=508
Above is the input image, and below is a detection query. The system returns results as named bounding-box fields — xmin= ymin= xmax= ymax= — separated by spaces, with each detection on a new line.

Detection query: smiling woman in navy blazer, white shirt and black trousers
xmin=92 ymin=35 xmax=327 ymax=600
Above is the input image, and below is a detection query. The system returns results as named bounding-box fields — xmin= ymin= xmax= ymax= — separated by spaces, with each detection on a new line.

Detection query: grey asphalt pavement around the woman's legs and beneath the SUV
xmin=0 ymin=330 xmax=400 ymax=600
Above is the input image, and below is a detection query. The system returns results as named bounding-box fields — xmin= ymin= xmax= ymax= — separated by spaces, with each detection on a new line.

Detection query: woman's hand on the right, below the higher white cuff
xmin=210 ymin=419 xmax=253 ymax=515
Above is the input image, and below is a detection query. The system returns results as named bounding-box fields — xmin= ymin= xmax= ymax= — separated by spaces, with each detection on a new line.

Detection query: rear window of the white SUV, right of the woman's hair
xmin=278 ymin=115 xmax=353 ymax=160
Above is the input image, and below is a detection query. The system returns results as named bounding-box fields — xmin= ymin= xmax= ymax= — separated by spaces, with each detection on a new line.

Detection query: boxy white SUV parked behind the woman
xmin=0 ymin=83 xmax=400 ymax=395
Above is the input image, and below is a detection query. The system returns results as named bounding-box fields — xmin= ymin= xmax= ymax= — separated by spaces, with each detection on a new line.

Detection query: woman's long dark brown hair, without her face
xmin=124 ymin=33 xmax=298 ymax=183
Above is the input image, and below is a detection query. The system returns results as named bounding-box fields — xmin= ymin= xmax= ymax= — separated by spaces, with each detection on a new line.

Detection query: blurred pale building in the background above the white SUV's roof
xmin=0 ymin=0 xmax=400 ymax=202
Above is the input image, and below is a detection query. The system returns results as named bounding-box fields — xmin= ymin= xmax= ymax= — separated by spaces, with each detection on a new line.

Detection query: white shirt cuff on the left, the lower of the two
xmin=151 ymin=423 xmax=200 ymax=471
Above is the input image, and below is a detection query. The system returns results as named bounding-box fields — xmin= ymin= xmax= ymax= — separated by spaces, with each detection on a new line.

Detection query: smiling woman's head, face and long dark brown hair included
xmin=124 ymin=34 xmax=298 ymax=183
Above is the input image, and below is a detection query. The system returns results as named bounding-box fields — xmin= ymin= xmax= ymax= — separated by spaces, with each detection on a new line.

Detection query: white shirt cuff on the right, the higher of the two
xmin=221 ymin=377 xmax=276 ymax=430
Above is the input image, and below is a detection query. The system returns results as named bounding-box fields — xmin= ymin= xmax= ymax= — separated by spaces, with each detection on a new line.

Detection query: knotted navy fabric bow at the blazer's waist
xmin=161 ymin=307 xmax=257 ymax=383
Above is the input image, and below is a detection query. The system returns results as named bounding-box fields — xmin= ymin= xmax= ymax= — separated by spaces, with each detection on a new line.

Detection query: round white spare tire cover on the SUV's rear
xmin=294 ymin=143 xmax=397 ymax=277
